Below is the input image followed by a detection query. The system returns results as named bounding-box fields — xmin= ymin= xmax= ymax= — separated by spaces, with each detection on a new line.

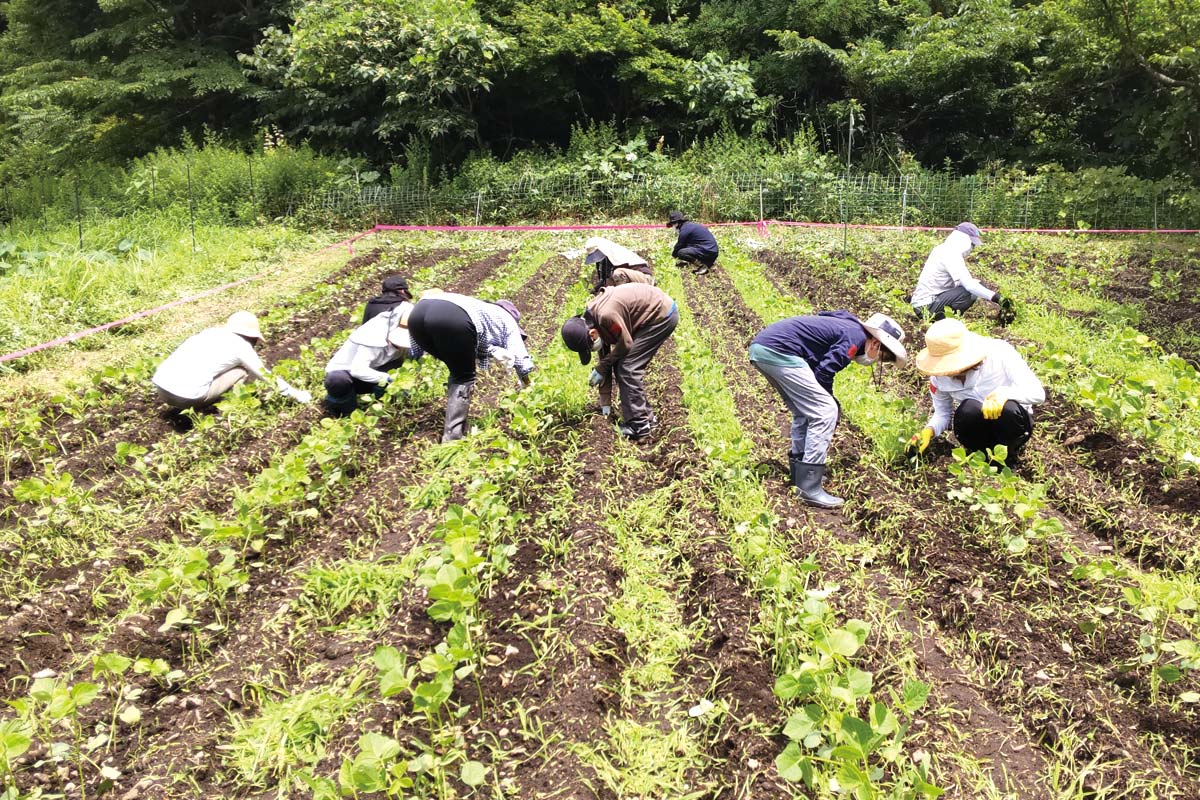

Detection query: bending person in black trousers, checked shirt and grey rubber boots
xmin=408 ymin=290 xmax=534 ymax=443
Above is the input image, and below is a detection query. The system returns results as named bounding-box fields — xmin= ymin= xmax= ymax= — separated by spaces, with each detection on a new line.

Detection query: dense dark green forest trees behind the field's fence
xmin=0 ymin=0 xmax=1200 ymax=179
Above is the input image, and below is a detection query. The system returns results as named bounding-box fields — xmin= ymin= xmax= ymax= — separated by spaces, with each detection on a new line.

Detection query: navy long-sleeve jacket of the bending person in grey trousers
xmin=754 ymin=311 xmax=866 ymax=395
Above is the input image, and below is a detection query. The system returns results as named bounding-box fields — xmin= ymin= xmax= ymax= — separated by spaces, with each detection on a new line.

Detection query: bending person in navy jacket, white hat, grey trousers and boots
xmin=750 ymin=311 xmax=908 ymax=509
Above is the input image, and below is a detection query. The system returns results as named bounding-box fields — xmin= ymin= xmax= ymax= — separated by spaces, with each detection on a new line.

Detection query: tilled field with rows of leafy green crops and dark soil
xmin=0 ymin=226 xmax=1200 ymax=800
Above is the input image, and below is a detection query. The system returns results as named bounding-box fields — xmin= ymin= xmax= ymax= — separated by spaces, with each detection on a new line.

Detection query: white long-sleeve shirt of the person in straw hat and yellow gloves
xmin=925 ymin=338 xmax=1046 ymax=437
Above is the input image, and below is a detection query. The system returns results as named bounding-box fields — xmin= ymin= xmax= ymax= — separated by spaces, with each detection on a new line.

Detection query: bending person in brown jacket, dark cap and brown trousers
xmin=563 ymin=283 xmax=679 ymax=440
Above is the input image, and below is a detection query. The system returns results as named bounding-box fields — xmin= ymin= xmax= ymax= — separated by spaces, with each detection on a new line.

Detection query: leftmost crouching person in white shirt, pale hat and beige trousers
xmin=150 ymin=311 xmax=312 ymax=409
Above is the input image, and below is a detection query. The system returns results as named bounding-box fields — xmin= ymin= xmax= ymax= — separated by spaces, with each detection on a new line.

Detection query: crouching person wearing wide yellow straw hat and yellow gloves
xmin=908 ymin=319 xmax=1046 ymax=465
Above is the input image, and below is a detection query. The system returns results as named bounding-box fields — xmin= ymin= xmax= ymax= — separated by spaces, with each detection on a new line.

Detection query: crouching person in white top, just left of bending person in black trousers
xmin=325 ymin=302 xmax=421 ymax=416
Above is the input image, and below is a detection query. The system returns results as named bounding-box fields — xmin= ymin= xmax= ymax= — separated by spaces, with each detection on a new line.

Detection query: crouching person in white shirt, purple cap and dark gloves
xmin=911 ymin=222 xmax=1015 ymax=325
